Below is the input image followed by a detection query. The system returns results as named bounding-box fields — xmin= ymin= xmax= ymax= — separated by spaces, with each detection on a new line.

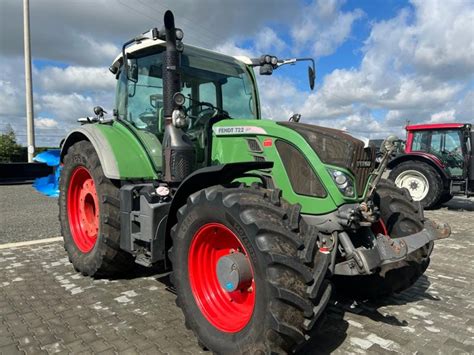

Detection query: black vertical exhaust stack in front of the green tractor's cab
xmin=162 ymin=10 xmax=196 ymax=184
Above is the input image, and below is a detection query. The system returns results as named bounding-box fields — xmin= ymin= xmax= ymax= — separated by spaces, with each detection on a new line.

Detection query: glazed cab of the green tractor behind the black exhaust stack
xmin=111 ymin=43 xmax=260 ymax=170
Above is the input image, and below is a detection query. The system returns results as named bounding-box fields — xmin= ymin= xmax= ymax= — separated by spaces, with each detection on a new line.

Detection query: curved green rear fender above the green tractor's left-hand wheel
xmin=60 ymin=121 xmax=158 ymax=180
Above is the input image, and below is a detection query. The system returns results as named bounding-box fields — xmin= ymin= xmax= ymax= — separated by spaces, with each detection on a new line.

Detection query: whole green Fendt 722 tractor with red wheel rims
xmin=59 ymin=11 xmax=449 ymax=354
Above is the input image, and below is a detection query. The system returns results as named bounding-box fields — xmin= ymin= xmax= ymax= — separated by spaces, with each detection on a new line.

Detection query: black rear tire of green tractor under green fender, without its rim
xmin=58 ymin=141 xmax=132 ymax=276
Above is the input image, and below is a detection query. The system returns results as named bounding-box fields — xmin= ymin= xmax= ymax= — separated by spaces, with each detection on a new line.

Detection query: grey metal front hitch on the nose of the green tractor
xmin=334 ymin=220 xmax=451 ymax=276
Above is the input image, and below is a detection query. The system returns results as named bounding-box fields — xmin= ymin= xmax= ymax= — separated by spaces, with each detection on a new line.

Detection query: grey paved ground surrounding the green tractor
xmin=0 ymin=186 xmax=474 ymax=354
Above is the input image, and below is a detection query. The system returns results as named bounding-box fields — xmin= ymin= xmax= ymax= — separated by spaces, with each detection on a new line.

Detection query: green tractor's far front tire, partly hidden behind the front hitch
xmin=332 ymin=179 xmax=433 ymax=299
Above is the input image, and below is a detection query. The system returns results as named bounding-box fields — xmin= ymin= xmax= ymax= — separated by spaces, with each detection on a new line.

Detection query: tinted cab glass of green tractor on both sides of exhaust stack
xmin=116 ymin=47 xmax=257 ymax=128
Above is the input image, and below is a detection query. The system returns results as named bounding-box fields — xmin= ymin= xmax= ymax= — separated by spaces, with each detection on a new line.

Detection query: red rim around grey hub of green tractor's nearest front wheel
xmin=188 ymin=223 xmax=255 ymax=333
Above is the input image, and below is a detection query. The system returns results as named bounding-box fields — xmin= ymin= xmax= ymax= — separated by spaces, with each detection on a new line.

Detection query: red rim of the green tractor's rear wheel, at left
xmin=67 ymin=166 xmax=99 ymax=253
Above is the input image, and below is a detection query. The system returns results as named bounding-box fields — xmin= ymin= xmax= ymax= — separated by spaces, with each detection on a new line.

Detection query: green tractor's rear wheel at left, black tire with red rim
xmin=59 ymin=141 xmax=131 ymax=276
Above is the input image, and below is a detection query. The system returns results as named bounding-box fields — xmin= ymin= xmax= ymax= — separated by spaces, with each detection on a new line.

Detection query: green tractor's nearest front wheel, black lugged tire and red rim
xmin=170 ymin=185 xmax=331 ymax=354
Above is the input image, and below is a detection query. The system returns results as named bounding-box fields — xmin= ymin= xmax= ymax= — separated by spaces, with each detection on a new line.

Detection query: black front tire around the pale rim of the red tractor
xmin=388 ymin=161 xmax=444 ymax=209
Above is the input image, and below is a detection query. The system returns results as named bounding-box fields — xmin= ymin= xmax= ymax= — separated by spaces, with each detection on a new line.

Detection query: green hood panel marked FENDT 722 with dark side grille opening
xmin=212 ymin=120 xmax=360 ymax=214
